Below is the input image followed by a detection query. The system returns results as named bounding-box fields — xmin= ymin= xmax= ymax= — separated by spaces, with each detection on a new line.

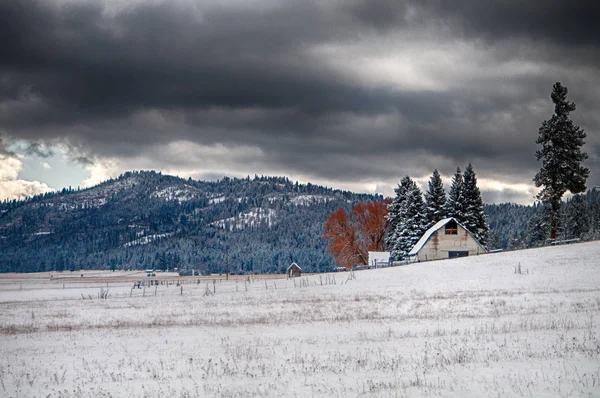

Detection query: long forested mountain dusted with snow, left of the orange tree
xmin=0 ymin=171 xmax=376 ymax=273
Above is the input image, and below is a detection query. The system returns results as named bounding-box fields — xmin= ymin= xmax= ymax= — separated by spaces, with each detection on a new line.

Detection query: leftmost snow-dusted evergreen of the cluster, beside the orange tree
xmin=392 ymin=176 xmax=425 ymax=260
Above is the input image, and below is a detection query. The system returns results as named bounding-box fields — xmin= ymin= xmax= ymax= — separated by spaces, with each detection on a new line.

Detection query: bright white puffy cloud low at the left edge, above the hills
xmin=0 ymin=154 xmax=53 ymax=200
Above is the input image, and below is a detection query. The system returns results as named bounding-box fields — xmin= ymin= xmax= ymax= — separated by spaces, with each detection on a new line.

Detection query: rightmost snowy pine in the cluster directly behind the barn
xmin=461 ymin=163 xmax=489 ymax=247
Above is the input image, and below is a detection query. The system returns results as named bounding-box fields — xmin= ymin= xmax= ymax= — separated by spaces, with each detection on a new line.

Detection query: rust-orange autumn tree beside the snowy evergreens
xmin=323 ymin=201 xmax=387 ymax=268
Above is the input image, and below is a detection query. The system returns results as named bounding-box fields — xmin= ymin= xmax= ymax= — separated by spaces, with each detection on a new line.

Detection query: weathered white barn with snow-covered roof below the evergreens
xmin=408 ymin=217 xmax=487 ymax=261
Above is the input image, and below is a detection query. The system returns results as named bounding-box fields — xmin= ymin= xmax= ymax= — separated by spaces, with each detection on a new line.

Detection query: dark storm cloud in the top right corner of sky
xmin=348 ymin=0 xmax=600 ymax=47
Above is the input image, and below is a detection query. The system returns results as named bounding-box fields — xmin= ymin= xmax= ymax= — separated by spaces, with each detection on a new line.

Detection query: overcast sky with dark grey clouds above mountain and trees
xmin=0 ymin=0 xmax=600 ymax=203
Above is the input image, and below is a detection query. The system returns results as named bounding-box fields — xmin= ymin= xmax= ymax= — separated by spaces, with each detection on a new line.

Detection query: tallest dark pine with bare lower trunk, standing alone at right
xmin=533 ymin=82 xmax=590 ymax=240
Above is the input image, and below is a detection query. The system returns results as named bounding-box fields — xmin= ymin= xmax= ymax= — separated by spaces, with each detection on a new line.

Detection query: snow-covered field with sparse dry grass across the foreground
xmin=0 ymin=242 xmax=600 ymax=397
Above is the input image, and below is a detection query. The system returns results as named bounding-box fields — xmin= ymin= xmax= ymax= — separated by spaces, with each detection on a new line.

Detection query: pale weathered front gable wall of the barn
xmin=418 ymin=225 xmax=485 ymax=261
